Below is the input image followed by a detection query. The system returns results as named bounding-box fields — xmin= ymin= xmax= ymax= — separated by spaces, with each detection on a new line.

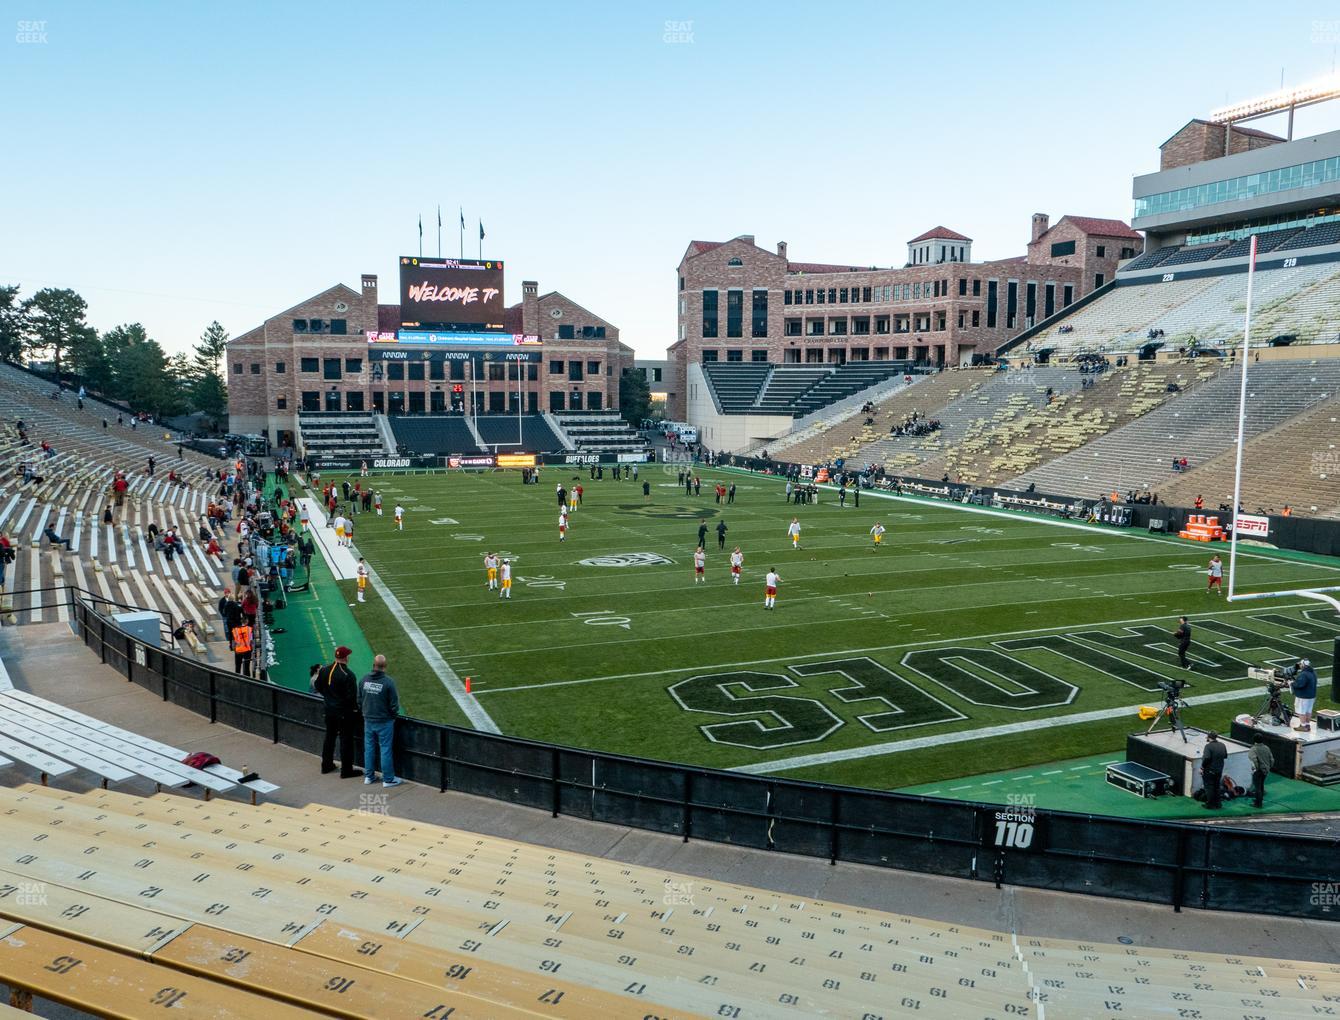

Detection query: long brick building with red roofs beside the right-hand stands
xmin=666 ymin=213 xmax=1142 ymax=418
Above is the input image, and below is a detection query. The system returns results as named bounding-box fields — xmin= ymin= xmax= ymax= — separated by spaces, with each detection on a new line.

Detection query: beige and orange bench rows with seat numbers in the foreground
xmin=0 ymin=785 xmax=1340 ymax=1020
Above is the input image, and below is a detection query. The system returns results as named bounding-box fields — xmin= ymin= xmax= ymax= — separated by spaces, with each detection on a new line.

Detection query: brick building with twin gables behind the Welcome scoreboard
xmin=228 ymin=275 xmax=632 ymax=444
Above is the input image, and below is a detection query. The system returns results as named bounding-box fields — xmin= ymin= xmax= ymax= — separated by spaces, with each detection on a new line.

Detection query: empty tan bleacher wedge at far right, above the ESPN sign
xmin=1159 ymin=399 xmax=1340 ymax=519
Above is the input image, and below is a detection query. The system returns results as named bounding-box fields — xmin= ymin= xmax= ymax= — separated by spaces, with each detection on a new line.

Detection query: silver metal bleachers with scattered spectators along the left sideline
xmin=0 ymin=366 xmax=235 ymax=658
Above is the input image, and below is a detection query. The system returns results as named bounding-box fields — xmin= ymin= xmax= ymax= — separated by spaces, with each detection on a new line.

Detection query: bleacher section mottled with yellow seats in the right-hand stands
xmin=919 ymin=358 xmax=1219 ymax=485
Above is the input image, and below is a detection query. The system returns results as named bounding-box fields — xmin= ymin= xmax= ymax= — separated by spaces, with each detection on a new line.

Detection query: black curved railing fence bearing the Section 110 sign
xmin=74 ymin=596 xmax=1340 ymax=919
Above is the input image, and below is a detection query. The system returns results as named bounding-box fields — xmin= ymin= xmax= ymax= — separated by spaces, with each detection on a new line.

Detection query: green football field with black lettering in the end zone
xmin=329 ymin=466 xmax=1340 ymax=788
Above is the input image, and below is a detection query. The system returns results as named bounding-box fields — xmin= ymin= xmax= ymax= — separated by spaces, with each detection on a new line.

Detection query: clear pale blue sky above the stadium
xmin=0 ymin=0 xmax=1340 ymax=357
